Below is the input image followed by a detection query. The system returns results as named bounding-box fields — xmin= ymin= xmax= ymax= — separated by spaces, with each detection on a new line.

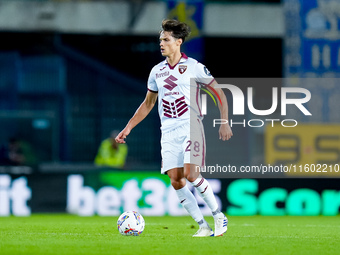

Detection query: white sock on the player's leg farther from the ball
xmin=191 ymin=177 xmax=221 ymax=218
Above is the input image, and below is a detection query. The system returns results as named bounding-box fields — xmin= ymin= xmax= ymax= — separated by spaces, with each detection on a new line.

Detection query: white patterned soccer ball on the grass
xmin=117 ymin=211 xmax=145 ymax=236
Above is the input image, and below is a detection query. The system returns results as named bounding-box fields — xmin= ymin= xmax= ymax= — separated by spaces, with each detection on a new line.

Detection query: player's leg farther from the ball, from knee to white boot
xmin=184 ymin=164 xmax=228 ymax=236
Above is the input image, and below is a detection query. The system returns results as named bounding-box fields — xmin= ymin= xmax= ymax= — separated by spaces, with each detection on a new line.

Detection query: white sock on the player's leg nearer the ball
xmin=176 ymin=185 xmax=205 ymax=223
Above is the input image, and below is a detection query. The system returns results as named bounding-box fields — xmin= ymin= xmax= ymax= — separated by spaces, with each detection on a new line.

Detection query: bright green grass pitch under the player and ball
xmin=0 ymin=214 xmax=340 ymax=255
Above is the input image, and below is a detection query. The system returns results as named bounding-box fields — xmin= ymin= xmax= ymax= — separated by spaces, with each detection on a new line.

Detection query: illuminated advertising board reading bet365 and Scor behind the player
xmin=0 ymin=171 xmax=340 ymax=216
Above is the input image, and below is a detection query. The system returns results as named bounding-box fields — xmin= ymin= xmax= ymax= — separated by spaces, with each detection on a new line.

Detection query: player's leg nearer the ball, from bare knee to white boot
xmin=166 ymin=167 xmax=214 ymax=237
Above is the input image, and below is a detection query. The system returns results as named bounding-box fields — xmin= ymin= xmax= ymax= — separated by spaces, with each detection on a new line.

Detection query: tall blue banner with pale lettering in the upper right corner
xmin=283 ymin=0 xmax=340 ymax=123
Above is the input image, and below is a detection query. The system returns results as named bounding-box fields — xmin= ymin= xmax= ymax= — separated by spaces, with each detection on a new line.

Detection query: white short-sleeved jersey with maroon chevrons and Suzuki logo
xmin=148 ymin=53 xmax=214 ymax=132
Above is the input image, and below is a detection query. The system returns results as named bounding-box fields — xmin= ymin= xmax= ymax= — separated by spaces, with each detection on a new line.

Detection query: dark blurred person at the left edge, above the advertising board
xmin=0 ymin=137 xmax=38 ymax=167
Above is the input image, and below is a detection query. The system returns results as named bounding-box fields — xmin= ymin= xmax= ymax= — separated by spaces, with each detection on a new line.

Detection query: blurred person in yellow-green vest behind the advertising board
xmin=94 ymin=130 xmax=128 ymax=168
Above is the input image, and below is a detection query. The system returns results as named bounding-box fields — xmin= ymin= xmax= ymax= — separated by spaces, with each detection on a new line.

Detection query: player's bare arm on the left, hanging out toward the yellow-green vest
xmin=116 ymin=91 xmax=158 ymax=143
